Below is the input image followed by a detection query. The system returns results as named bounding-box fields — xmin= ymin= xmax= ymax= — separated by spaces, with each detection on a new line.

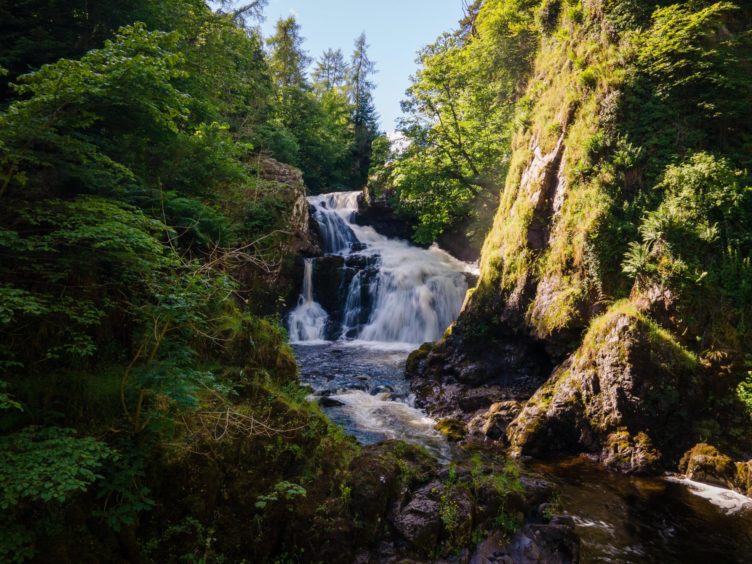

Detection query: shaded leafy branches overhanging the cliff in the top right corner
xmin=621 ymin=2 xmax=752 ymax=172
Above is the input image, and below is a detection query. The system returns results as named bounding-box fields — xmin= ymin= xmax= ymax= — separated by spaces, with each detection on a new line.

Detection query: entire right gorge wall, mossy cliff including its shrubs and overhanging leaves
xmin=408 ymin=0 xmax=752 ymax=484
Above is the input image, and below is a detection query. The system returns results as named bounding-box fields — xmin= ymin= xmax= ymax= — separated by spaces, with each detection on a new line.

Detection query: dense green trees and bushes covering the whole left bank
xmin=0 ymin=0 xmax=384 ymax=561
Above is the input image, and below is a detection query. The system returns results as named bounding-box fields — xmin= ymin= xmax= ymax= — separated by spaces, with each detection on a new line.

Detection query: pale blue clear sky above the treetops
xmin=262 ymin=0 xmax=462 ymax=132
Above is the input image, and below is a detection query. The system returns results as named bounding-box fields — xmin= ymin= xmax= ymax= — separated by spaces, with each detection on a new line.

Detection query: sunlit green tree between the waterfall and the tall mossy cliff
xmin=389 ymin=0 xmax=538 ymax=243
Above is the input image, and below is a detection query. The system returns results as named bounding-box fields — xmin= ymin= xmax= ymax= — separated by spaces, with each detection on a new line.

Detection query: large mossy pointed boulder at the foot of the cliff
xmin=507 ymin=308 xmax=699 ymax=472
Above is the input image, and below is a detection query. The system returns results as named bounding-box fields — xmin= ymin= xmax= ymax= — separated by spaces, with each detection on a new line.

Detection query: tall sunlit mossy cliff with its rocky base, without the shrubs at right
xmin=407 ymin=1 xmax=752 ymax=490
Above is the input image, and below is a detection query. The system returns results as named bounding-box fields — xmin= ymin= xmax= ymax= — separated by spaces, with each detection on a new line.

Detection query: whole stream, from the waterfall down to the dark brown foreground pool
xmin=287 ymin=192 xmax=752 ymax=563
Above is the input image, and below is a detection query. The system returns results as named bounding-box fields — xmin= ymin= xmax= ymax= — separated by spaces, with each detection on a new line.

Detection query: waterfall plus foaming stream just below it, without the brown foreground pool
xmin=288 ymin=192 xmax=471 ymax=457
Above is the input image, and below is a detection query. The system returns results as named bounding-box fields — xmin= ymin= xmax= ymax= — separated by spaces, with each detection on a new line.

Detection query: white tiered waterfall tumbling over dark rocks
xmin=288 ymin=192 xmax=469 ymax=345
